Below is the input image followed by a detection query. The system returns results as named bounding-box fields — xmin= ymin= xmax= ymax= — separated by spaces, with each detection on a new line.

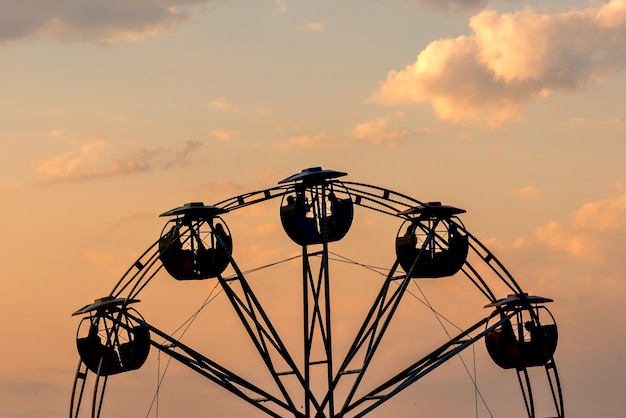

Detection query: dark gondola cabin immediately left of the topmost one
xmin=159 ymin=202 xmax=233 ymax=280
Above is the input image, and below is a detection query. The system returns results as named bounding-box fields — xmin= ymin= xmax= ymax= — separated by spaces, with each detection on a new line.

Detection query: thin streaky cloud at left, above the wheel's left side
xmin=32 ymin=139 xmax=201 ymax=184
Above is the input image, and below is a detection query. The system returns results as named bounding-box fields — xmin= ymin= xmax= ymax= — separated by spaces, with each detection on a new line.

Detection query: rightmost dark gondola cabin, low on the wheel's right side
xmin=485 ymin=295 xmax=558 ymax=370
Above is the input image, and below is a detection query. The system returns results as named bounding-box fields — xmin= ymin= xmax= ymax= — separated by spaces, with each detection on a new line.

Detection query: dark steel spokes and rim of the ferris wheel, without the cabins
xmin=70 ymin=180 xmax=564 ymax=418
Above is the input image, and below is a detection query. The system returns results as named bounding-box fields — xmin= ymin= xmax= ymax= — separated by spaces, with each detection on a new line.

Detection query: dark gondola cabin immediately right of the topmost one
xmin=396 ymin=202 xmax=469 ymax=278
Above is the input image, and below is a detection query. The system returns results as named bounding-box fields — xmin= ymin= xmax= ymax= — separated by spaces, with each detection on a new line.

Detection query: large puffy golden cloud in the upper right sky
xmin=370 ymin=0 xmax=626 ymax=128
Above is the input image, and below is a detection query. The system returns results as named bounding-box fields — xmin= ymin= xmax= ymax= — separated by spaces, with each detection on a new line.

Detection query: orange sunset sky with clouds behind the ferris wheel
xmin=0 ymin=0 xmax=626 ymax=418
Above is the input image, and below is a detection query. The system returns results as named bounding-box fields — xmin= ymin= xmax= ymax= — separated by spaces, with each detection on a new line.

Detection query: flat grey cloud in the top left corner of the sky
xmin=0 ymin=0 xmax=211 ymax=44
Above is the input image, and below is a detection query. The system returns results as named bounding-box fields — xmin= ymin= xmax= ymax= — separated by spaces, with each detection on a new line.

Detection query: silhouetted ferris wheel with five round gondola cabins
xmin=69 ymin=167 xmax=564 ymax=418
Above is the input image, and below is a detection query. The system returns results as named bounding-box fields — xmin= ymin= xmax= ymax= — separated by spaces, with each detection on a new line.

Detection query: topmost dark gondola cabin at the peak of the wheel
xmin=280 ymin=167 xmax=354 ymax=246
